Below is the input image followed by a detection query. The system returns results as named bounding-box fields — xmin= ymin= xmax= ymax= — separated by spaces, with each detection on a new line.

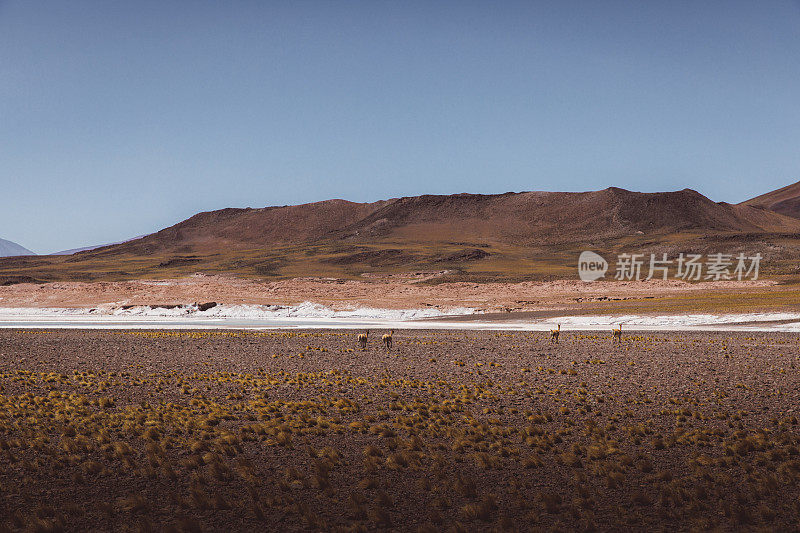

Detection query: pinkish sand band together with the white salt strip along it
xmin=0 ymin=273 xmax=800 ymax=332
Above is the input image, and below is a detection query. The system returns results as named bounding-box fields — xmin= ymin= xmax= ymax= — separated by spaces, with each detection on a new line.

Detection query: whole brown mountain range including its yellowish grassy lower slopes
xmin=0 ymin=184 xmax=800 ymax=280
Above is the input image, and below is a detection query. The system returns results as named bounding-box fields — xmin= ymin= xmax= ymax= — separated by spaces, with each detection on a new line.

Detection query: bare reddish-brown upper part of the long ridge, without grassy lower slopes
xmin=81 ymin=187 xmax=800 ymax=256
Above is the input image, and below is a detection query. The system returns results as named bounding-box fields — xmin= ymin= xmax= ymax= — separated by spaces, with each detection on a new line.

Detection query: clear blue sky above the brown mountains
xmin=0 ymin=0 xmax=800 ymax=253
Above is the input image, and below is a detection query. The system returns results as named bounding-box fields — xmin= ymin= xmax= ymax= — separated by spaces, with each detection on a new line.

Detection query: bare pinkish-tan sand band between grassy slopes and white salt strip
xmin=0 ymin=272 xmax=800 ymax=314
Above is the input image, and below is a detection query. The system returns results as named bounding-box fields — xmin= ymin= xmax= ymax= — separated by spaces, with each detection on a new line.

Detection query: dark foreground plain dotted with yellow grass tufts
xmin=0 ymin=330 xmax=800 ymax=531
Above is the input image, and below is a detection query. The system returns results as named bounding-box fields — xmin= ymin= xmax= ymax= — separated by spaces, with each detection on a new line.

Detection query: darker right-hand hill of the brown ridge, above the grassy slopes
xmin=332 ymin=187 xmax=800 ymax=244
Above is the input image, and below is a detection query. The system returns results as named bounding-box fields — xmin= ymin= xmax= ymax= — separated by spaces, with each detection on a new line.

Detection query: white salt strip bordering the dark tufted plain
xmin=0 ymin=305 xmax=800 ymax=332
